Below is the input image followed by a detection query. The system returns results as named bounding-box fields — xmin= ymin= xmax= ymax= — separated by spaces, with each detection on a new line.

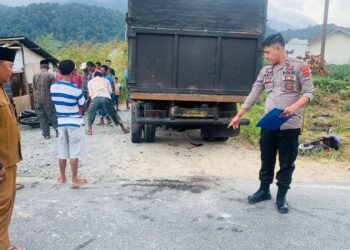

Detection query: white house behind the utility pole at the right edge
xmin=307 ymin=28 xmax=350 ymax=64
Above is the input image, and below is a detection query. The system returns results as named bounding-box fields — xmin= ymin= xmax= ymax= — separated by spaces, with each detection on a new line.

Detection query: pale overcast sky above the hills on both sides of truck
xmin=0 ymin=0 xmax=350 ymax=28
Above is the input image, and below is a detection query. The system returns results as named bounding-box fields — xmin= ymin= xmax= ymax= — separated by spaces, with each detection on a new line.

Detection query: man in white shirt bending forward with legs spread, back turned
xmin=86 ymin=71 xmax=129 ymax=135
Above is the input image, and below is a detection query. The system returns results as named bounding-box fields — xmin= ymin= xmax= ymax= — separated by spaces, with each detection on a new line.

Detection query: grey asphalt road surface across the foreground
xmin=10 ymin=177 xmax=350 ymax=250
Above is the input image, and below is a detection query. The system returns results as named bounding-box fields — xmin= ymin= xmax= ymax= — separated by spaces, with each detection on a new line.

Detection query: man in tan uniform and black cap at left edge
xmin=0 ymin=47 xmax=22 ymax=250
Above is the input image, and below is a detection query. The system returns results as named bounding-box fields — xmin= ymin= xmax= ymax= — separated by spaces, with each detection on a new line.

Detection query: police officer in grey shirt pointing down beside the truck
xmin=228 ymin=33 xmax=314 ymax=213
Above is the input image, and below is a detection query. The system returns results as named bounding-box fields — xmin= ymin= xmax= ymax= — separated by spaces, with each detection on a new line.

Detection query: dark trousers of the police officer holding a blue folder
xmin=259 ymin=129 xmax=300 ymax=189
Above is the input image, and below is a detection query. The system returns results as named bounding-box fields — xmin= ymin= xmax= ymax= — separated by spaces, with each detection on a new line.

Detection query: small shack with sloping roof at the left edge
xmin=0 ymin=36 xmax=58 ymax=112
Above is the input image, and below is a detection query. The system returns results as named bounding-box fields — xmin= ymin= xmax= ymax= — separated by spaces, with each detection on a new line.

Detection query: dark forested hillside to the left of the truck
xmin=0 ymin=3 xmax=125 ymax=42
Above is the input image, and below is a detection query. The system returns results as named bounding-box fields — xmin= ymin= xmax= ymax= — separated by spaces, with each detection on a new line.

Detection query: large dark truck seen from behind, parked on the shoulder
xmin=126 ymin=0 xmax=267 ymax=143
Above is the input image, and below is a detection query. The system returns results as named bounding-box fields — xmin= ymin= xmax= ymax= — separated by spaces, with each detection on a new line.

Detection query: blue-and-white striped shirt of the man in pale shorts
xmin=50 ymin=81 xmax=85 ymax=127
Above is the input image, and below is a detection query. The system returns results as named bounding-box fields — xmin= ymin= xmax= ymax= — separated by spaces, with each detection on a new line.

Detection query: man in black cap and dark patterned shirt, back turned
xmin=33 ymin=60 xmax=58 ymax=139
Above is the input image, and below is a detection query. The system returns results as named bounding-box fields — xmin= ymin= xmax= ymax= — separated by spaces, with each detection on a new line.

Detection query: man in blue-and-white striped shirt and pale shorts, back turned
xmin=50 ymin=60 xmax=87 ymax=188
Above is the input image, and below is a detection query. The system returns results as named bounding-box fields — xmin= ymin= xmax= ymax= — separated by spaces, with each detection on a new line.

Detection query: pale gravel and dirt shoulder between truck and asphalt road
xmin=19 ymin=112 xmax=350 ymax=183
